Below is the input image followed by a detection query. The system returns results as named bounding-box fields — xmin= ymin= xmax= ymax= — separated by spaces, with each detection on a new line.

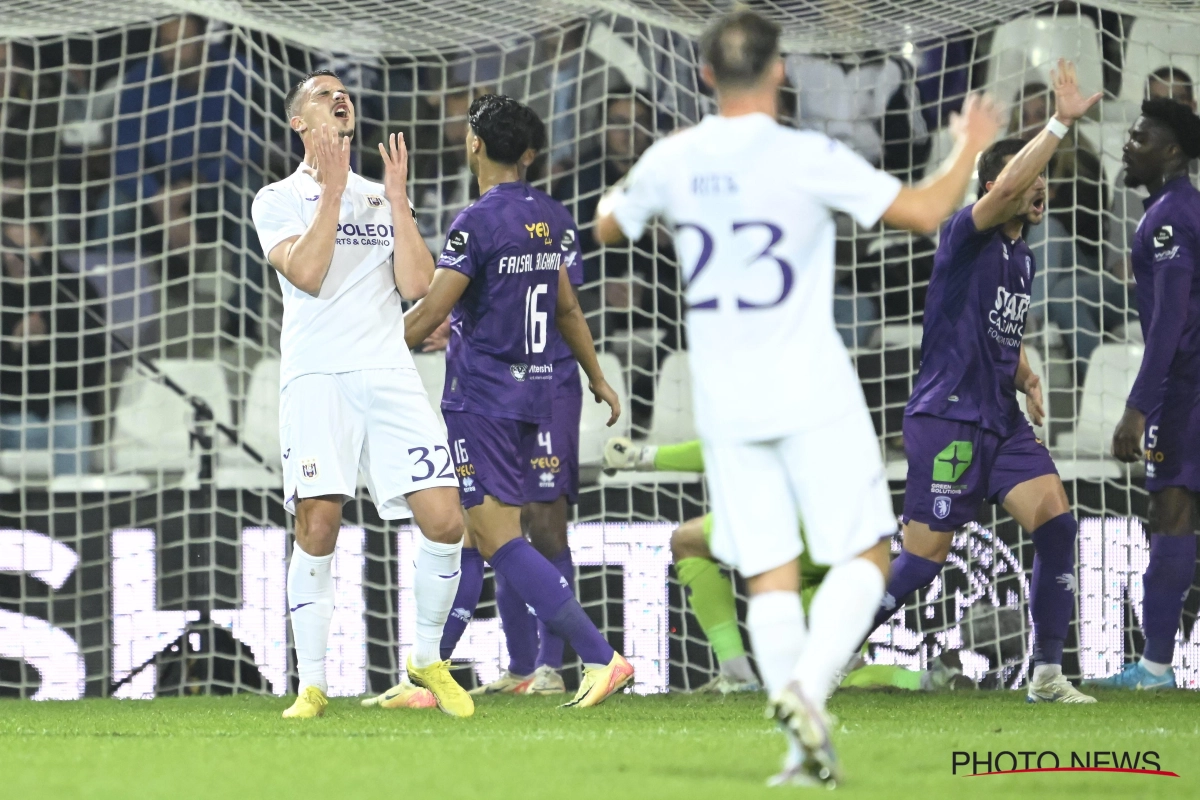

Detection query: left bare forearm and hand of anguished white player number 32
xmin=266 ymin=125 xmax=350 ymax=297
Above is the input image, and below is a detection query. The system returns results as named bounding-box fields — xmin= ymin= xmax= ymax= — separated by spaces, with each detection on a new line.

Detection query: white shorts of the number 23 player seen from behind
xmin=704 ymin=407 xmax=896 ymax=577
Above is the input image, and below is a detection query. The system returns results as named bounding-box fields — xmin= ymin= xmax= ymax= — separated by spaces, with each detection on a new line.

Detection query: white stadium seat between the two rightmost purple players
xmin=1055 ymin=344 xmax=1145 ymax=456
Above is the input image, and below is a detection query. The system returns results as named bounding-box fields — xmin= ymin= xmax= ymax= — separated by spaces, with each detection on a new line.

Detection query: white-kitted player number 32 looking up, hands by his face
xmin=252 ymin=70 xmax=474 ymax=718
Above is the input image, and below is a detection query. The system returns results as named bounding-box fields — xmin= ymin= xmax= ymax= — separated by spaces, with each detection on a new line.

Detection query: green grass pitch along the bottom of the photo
xmin=0 ymin=691 xmax=1200 ymax=800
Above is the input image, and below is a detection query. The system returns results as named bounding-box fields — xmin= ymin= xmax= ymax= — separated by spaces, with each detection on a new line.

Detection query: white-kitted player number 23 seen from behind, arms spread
xmin=596 ymin=11 xmax=1001 ymax=784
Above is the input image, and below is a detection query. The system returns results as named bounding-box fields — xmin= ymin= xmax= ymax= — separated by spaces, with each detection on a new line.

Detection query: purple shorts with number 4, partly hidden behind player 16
xmin=524 ymin=369 xmax=583 ymax=505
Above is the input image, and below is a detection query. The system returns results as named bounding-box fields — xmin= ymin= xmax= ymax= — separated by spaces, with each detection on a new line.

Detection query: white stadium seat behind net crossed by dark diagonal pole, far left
xmin=110 ymin=359 xmax=233 ymax=473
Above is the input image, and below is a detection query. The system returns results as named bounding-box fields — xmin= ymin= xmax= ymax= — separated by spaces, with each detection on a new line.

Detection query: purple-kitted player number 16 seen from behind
xmin=404 ymin=95 xmax=634 ymax=706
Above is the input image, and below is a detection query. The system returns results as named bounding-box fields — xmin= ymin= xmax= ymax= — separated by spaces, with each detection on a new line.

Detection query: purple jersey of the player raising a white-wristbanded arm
xmin=905 ymin=205 xmax=1036 ymax=437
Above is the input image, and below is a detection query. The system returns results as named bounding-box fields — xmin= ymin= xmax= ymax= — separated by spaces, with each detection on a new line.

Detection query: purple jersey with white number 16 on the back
xmin=437 ymin=182 xmax=578 ymax=422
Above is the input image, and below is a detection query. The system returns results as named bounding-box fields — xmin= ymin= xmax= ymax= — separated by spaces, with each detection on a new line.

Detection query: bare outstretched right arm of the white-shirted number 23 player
xmin=883 ymin=95 xmax=1003 ymax=235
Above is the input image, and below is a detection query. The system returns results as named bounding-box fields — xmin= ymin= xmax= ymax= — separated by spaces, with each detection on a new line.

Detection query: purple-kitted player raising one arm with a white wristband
xmin=875 ymin=60 xmax=1100 ymax=703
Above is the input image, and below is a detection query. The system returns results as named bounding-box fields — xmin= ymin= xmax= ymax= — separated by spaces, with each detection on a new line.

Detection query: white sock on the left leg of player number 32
xmin=288 ymin=542 xmax=334 ymax=693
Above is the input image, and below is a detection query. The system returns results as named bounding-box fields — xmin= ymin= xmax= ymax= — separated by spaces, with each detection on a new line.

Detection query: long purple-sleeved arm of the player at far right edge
xmin=1112 ymin=225 xmax=1195 ymax=462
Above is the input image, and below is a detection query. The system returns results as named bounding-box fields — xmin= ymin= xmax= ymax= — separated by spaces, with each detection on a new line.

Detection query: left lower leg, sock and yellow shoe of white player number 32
xmin=283 ymin=495 xmax=342 ymax=718
